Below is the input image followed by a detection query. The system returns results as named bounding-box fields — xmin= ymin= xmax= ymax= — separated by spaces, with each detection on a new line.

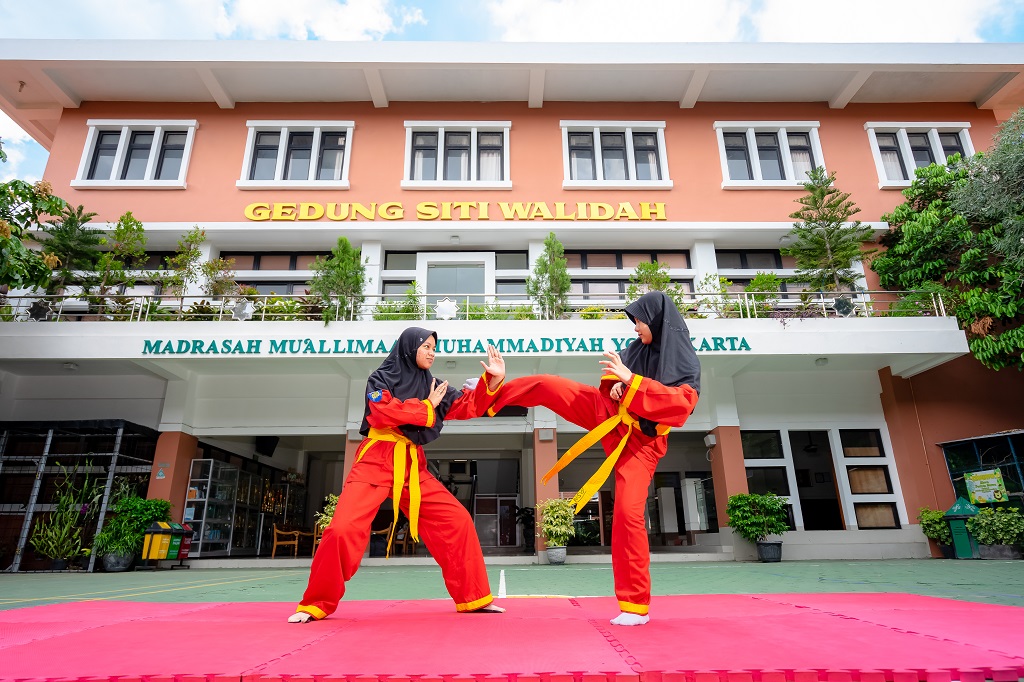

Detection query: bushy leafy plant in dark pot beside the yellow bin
xmin=93 ymin=481 xmax=171 ymax=572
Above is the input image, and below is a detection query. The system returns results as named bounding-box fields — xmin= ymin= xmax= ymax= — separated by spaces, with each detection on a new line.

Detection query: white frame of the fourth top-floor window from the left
xmin=558 ymin=121 xmax=673 ymax=189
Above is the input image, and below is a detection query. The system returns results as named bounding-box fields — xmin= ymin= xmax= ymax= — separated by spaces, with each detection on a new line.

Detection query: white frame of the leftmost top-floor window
xmin=71 ymin=119 xmax=199 ymax=189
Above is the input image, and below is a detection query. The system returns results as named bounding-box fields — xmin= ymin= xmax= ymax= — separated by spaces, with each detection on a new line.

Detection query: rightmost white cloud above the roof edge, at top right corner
xmin=751 ymin=0 xmax=1022 ymax=43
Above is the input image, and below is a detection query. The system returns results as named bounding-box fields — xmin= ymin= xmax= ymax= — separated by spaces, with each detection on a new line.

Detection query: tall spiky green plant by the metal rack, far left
xmin=29 ymin=461 xmax=101 ymax=570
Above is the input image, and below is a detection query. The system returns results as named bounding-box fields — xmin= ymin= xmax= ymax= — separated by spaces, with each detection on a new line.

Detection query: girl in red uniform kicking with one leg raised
xmin=487 ymin=292 xmax=700 ymax=626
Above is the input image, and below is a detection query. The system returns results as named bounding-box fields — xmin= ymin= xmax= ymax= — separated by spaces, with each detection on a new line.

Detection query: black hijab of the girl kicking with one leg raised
xmin=622 ymin=291 xmax=700 ymax=436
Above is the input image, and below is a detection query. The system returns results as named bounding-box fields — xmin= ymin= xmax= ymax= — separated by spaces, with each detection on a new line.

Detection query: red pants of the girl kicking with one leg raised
xmin=492 ymin=375 xmax=668 ymax=614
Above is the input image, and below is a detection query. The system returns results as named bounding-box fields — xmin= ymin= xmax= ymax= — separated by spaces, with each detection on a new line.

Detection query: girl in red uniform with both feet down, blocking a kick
xmin=288 ymin=327 xmax=505 ymax=623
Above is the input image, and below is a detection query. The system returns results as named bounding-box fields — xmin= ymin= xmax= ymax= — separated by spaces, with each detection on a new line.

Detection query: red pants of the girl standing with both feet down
xmin=296 ymin=443 xmax=494 ymax=619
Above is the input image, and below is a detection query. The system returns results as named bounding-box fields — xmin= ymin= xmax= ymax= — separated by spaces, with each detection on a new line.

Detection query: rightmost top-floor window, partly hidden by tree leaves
xmin=864 ymin=122 xmax=974 ymax=189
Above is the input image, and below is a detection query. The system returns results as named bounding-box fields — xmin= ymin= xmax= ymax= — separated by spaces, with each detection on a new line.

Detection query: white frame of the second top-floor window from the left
xmin=234 ymin=121 xmax=355 ymax=189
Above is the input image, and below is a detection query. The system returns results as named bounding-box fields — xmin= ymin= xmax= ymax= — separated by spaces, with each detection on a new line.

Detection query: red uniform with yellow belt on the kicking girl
xmin=487 ymin=374 xmax=697 ymax=615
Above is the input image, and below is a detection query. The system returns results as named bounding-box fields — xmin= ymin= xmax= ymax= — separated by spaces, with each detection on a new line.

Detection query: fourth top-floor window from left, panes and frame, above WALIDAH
xmin=561 ymin=121 xmax=672 ymax=189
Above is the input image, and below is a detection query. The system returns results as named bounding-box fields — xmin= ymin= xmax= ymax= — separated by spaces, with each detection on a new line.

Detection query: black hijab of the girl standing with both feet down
xmin=359 ymin=327 xmax=461 ymax=445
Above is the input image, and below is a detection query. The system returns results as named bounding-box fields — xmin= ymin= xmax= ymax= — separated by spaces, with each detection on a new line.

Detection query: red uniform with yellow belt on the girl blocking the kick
xmin=296 ymin=375 xmax=498 ymax=620
